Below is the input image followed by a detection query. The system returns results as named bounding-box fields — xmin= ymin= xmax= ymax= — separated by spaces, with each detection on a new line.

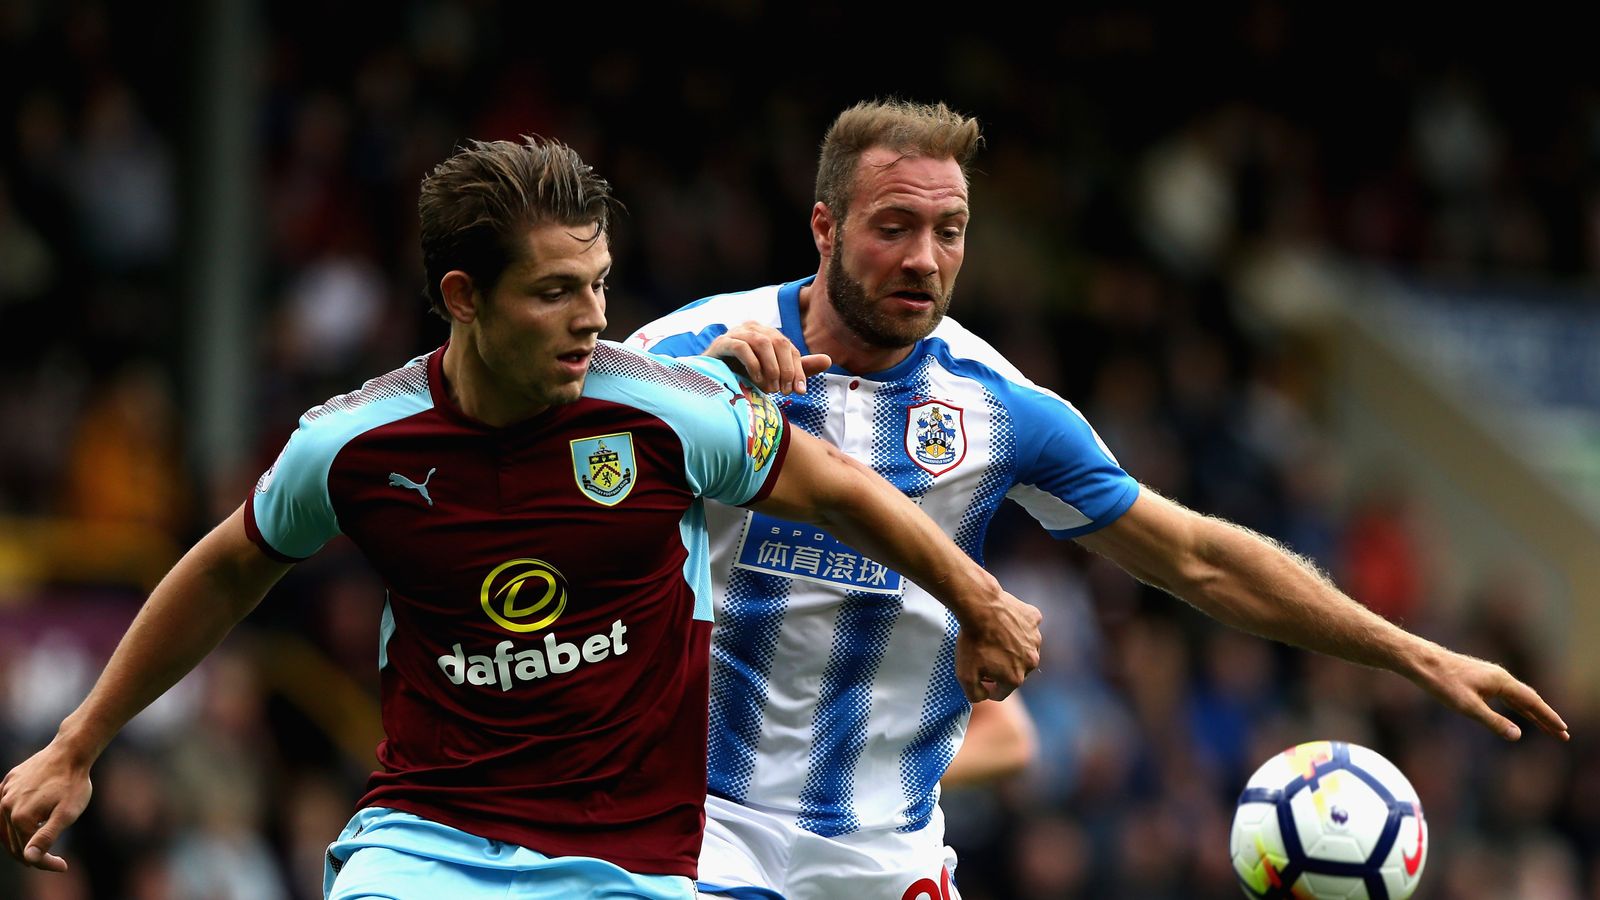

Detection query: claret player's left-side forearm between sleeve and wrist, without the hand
xmin=56 ymin=514 xmax=286 ymax=764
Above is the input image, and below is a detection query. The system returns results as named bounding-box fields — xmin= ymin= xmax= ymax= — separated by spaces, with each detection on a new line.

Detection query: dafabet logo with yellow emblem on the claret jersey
xmin=438 ymin=559 xmax=627 ymax=690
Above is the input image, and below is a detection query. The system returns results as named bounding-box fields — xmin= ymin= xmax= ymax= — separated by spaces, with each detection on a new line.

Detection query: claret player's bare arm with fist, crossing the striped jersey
xmin=750 ymin=429 xmax=1042 ymax=701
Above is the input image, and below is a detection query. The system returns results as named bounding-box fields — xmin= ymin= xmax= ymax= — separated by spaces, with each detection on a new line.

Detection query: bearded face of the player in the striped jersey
xmin=824 ymin=147 xmax=968 ymax=348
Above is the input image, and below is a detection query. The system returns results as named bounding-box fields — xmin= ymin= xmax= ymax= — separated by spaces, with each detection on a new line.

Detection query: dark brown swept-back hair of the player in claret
xmin=416 ymin=135 xmax=621 ymax=320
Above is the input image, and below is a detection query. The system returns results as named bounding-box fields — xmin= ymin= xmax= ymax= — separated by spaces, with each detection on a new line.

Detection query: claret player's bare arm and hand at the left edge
xmin=0 ymin=508 xmax=290 ymax=871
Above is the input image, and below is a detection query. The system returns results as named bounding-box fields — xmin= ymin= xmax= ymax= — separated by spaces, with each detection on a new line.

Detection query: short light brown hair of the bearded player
xmin=816 ymin=99 xmax=982 ymax=218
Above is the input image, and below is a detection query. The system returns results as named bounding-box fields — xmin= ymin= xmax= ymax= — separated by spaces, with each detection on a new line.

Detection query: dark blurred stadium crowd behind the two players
xmin=0 ymin=0 xmax=1600 ymax=900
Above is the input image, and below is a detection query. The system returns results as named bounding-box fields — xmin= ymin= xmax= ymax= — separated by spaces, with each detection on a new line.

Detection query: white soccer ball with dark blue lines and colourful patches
xmin=1229 ymin=741 xmax=1427 ymax=900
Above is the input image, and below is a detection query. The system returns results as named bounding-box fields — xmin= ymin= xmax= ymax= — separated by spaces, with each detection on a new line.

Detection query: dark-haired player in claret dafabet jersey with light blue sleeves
xmin=0 ymin=139 xmax=1038 ymax=900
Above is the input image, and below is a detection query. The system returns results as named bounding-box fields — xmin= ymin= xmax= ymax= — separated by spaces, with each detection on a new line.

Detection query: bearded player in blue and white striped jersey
xmin=630 ymin=101 xmax=1566 ymax=900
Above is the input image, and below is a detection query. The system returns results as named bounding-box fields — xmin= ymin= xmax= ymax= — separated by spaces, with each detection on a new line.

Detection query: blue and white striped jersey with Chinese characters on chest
xmin=630 ymin=280 xmax=1139 ymax=836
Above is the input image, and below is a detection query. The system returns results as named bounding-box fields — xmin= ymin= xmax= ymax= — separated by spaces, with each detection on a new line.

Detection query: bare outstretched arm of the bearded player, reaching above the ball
xmin=1078 ymin=488 xmax=1568 ymax=740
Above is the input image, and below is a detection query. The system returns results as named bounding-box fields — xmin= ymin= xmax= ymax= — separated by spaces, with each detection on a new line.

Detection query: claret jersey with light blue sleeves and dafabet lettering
xmin=246 ymin=343 xmax=786 ymax=878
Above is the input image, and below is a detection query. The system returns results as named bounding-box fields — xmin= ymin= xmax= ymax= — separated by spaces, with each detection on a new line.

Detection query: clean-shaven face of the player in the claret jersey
xmin=477 ymin=224 xmax=611 ymax=412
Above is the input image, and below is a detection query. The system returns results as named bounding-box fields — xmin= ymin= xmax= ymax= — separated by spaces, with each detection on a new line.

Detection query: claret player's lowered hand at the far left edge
xmin=0 ymin=743 xmax=94 ymax=871
